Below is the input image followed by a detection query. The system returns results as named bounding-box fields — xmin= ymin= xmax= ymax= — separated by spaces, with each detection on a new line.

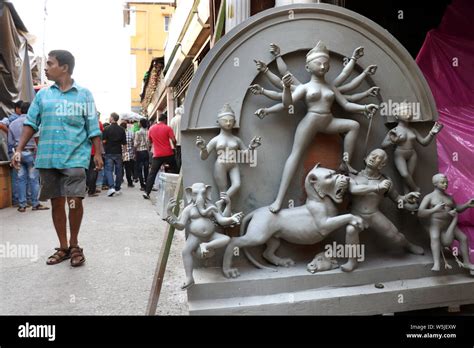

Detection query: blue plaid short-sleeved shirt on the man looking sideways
xmin=24 ymin=82 xmax=101 ymax=169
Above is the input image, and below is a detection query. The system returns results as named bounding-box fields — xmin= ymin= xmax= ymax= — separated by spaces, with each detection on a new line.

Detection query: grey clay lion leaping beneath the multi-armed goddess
xmin=222 ymin=164 xmax=364 ymax=278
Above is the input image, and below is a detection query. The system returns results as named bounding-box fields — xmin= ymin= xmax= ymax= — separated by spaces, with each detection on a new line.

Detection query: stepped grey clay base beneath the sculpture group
xmin=188 ymin=254 xmax=474 ymax=315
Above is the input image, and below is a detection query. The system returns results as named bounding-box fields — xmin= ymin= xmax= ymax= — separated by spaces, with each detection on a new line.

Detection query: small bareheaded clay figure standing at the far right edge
xmin=418 ymin=174 xmax=474 ymax=275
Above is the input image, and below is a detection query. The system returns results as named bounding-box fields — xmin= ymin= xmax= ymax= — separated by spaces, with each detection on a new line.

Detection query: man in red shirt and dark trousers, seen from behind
xmin=143 ymin=115 xmax=178 ymax=199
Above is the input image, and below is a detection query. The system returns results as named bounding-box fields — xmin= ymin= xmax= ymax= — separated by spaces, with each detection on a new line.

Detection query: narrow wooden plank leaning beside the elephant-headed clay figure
xmin=146 ymin=173 xmax=183 ymax=315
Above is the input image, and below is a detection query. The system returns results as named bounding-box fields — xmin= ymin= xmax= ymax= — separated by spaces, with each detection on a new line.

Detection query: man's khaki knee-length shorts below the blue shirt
xmin=39 ymin=168 xmax=86 ymax=201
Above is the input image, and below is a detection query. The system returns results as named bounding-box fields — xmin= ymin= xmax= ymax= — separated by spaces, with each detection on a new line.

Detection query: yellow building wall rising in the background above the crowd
xmin=130 ymin=3 xmax=174 ymax=108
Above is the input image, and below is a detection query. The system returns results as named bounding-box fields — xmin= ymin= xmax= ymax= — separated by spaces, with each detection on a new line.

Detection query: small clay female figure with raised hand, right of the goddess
xmin=382 ymin=103 xmax=443 ymax=192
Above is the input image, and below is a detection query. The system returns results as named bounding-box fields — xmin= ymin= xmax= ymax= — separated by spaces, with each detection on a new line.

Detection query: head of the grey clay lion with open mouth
xmin=305 ymin=163 xmax=349 ymax=203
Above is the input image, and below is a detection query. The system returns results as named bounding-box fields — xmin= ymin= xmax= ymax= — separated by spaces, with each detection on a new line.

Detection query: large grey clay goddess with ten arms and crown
xmin=250 ymin=41 xmax=378 ymax=213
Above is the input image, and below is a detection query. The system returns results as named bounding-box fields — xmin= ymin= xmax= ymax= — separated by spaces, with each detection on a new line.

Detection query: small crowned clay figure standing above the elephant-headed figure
xmin=196 ymin=104 xmax=261 ymax=209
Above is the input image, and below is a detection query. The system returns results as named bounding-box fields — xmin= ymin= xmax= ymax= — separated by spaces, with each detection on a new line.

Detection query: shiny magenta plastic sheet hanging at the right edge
xmin=416 ymin=0 xmax=474 ymax=260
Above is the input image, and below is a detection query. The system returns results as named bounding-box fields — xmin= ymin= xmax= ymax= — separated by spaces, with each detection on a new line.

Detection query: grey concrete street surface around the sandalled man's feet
xmin=0 ymin=187 xmax=188 ymax=315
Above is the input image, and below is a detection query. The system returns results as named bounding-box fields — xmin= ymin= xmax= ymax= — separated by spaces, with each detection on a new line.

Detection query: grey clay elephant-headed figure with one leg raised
xmin=166 ymin=183 xmax=243 ymax=290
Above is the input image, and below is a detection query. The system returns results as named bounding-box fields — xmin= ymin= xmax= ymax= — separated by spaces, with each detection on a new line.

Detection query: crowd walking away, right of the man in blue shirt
xmin=87 ymin=112 xmax=180 ymax=199
